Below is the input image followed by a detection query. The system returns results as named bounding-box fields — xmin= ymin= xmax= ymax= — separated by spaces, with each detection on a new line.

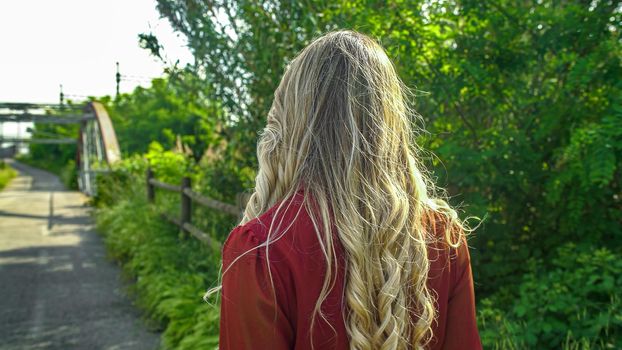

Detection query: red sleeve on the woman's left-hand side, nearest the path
xmin=219 ymin=226 xmax=295 ymax=350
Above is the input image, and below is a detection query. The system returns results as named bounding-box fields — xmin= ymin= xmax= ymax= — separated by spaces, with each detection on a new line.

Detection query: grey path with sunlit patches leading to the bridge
xmin=0 ymin=160 xmax=160 ymax=350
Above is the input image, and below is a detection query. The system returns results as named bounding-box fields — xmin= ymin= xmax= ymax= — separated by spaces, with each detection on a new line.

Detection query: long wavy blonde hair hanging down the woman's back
xmin=210 ymin=30 xmax=478 ymax=349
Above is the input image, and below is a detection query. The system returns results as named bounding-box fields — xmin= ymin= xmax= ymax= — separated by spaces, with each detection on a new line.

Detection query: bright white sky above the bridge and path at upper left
xmin=0 ymin=0 xmax=192 ymax=103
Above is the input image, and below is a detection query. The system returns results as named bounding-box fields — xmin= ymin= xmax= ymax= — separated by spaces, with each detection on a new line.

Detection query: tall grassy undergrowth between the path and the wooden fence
xmin=96 ymin=178 xmax=229 ymax=349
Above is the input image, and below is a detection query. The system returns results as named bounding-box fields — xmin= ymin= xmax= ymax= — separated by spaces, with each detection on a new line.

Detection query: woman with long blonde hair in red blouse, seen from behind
xmin=208 ymin=31 xmax=481 ymax=349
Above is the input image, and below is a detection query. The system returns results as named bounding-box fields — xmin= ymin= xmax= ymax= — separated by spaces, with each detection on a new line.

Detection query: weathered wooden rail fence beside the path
xmin=147 ymin=168 xmax=248 ymax=249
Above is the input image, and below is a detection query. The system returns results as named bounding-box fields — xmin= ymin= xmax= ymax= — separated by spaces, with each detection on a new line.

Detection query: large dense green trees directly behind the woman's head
xmin=158 ymin=0 xmax=622 ymax=295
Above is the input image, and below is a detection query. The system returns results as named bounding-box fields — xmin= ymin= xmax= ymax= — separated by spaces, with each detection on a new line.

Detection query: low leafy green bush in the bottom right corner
xmin=479 ymin=242 xmax=622 ymax=349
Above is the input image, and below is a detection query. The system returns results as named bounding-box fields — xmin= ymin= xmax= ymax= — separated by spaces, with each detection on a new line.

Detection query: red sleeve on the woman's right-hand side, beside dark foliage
xmin=443 ymin=238 xmax=482 ymax=350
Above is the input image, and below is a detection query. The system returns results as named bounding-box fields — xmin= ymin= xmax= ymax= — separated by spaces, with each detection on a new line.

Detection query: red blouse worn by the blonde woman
xmin=220 ymin=190 xmax=482 ymax=350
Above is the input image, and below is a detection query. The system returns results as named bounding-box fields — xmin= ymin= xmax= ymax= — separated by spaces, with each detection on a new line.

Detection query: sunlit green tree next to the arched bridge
xmin=103 ymin=69 xmax=221 ymax=160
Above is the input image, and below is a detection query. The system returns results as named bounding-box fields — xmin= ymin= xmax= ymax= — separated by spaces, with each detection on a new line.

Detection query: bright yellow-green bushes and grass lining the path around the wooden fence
xmin=95 ymin=146 xmax=235 ymax=349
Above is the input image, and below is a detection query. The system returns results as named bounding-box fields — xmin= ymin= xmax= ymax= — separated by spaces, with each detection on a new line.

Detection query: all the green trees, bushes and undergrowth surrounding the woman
xmin=34 ymin=0 xmax=622 ymax=349
